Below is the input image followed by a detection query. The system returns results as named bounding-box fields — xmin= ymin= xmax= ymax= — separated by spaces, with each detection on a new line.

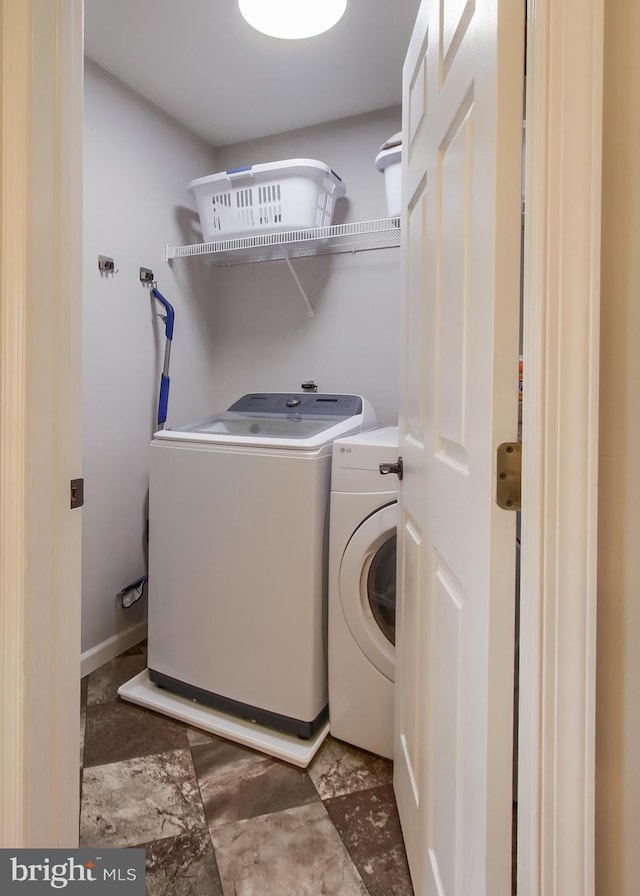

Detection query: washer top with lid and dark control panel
xmin=154 ymin=392 xmax=376 ymax=450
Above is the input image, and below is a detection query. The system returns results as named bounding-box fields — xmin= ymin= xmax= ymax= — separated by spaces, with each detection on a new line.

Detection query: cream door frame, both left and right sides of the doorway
xmin=0 ymin=0 xmax=604 ymax=884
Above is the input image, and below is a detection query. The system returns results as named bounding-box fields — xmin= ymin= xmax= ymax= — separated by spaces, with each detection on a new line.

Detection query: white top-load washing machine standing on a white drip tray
xmin=144 ymin=392 xmax=376 ymax=755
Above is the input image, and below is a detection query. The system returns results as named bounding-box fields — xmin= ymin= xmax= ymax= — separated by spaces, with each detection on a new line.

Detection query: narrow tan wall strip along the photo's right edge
xmin=596 ymin=0 xmax=640 ymax=896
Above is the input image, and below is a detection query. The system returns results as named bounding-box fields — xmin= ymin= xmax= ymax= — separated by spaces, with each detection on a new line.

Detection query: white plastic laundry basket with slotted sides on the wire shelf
xmin=188 ymin=159 xmax=346 ymax=242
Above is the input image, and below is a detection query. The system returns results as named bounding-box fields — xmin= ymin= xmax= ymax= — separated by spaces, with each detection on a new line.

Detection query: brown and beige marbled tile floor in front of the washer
xmin=80 ymin=643 xmax=413 ymax=896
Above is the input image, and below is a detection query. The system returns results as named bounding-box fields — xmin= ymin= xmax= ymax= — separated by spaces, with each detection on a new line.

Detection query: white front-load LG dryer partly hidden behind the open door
xmin=329 ymin=426 xmax=398 ymax=758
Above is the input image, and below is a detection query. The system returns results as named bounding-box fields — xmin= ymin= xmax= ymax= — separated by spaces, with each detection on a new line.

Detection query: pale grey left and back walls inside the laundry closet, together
xmin=82 ymin=68 xmax=401 ymax=656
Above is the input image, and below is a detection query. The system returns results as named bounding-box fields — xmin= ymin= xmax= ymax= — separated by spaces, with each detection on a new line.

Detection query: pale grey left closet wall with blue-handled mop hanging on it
xmin=82 ymin=62 xmax=216 ymax=652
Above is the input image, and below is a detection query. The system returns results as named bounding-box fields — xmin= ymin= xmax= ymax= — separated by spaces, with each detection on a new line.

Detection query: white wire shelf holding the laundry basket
xmin=165 ymin=218 xmax=400 ymax=265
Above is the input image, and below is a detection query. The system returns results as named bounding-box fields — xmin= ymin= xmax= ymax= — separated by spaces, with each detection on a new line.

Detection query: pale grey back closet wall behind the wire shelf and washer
xmin=209 ymin=107 xmax=401 ymax=424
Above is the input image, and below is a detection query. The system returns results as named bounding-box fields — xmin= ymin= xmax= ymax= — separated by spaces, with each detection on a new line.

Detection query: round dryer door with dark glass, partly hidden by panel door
xmin=340 ymin=501 xmax=398 ymax=681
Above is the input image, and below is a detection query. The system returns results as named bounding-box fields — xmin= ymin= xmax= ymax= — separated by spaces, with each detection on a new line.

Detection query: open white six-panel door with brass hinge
xmin=394 ymin=0 xmax=525 ymax=896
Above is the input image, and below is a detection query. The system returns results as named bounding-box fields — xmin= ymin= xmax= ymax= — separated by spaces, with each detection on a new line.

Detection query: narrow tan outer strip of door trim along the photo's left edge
xmin=0 ymin=0 xmax=29 ymax=846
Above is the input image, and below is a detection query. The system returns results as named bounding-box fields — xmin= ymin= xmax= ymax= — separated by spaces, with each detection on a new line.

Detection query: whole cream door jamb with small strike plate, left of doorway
xmin=0 ymin=0 xmax=83 ymax=848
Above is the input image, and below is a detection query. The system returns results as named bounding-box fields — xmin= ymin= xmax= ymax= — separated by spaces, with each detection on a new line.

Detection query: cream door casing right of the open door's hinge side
xmin=518 ymin=0 xmax=604 ymax=896
